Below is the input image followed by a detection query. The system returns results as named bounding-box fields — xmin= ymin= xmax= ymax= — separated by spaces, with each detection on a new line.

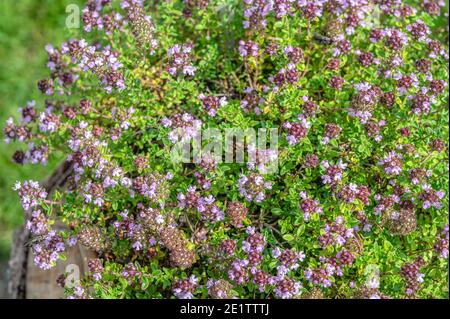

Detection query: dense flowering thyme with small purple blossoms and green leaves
xmin=4 ymin=0 xmax=448 ymax=298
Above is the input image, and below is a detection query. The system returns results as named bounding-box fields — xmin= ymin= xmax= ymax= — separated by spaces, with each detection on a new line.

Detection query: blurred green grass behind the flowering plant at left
xmin=0 ymin=0 xmax=83 ymax=261
